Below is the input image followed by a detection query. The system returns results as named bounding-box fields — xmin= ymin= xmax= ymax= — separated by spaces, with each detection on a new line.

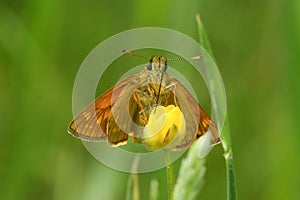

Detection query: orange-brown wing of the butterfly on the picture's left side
xmin=68 ymin=71 xmax=145 ymax=146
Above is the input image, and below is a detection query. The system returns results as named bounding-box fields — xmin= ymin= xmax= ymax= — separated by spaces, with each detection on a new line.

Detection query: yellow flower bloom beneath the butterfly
xmin=143 ymin=105 xmax=185 ymax=150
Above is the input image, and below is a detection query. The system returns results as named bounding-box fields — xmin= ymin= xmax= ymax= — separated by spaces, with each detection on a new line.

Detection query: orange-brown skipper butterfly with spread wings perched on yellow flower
xmin=68 ymin=50 xmax=220 ymax=150
